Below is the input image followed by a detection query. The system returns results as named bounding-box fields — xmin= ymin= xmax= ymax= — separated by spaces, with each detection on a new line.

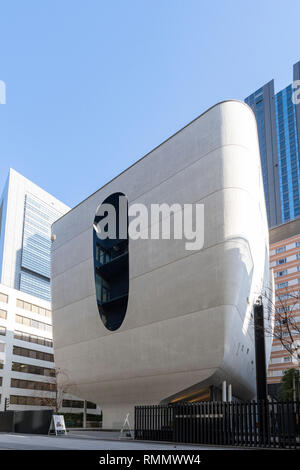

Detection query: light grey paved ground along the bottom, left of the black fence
xmin=0 ymin=431 xmax=232 ymax=450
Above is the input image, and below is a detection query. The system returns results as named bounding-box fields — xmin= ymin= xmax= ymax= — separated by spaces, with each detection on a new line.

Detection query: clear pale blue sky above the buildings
xmin=0 ymin=0 xmax=300 ymax=206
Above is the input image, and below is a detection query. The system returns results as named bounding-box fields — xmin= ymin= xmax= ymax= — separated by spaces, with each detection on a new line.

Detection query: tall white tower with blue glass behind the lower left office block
xmin=0 ymin=169 xmax=69 ymax=301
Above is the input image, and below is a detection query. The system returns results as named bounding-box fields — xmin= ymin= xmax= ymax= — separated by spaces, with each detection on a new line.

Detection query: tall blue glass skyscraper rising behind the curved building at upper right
xmin=245 ymin=62 xmax=300 ymax=227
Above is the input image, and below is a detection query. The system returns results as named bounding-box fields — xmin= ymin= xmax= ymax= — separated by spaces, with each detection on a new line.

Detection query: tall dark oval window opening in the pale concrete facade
xmin=93 ymin=193 xmax=129 ymax=331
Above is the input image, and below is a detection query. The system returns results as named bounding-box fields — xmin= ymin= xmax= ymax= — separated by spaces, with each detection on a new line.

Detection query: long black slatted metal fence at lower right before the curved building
xmin=135 ymin=401 xmax=300 ymax=448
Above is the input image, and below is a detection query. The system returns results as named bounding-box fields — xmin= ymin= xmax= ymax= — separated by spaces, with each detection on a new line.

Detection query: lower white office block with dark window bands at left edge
xmin=0 ymin=284 xmax=99 ymax=419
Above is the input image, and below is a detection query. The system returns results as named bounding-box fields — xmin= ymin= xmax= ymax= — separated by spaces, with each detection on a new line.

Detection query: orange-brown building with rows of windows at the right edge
xmin=268 ymin=218 xmax=300 ymax=395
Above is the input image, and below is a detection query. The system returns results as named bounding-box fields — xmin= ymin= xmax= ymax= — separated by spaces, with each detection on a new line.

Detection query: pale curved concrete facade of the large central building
xmin=52 ymin=101 xmax=271 ymax=427
